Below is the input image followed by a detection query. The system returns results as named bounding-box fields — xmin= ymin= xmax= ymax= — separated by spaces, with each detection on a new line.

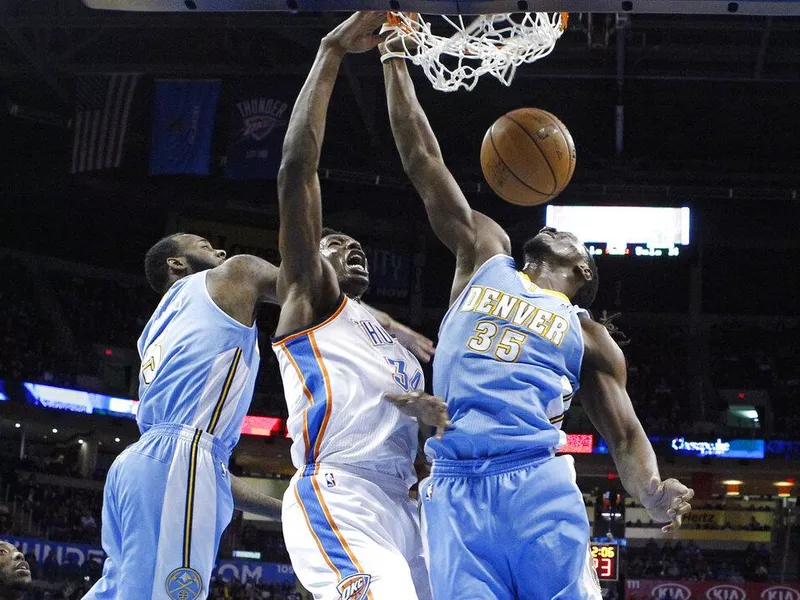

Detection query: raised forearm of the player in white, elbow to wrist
xmin=281 ymin=39 xmax=344 ymax=178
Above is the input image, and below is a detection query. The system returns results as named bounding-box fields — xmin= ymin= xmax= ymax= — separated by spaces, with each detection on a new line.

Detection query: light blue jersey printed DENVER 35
xmin=426 ymin=255 xmax=586 ymax=460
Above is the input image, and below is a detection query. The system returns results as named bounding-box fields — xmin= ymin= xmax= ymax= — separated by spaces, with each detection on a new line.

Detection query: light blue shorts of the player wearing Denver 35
xmin=420 ymin=453 xmax=601 ymax=600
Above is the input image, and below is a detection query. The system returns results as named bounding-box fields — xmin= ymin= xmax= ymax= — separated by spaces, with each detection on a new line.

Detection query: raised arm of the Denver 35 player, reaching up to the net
xmin=383 ymin=51 xmax=511 ymax=299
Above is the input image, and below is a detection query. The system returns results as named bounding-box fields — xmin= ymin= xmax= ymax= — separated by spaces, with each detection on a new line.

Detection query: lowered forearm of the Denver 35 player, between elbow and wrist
xmin=606 ymin=419 xmax=660 ymax=501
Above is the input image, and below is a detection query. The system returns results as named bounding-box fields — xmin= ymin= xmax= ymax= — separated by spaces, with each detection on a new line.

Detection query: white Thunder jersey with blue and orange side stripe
xmin=273 ymin=296 xmax=425 ymax=486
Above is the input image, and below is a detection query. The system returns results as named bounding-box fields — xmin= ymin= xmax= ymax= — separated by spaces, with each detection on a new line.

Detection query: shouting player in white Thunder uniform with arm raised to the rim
xmin=273 ymin=13 xmax=447 ymax=600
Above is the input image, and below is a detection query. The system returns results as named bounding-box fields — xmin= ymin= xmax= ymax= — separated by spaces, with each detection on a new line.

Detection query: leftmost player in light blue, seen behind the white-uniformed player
xmin=85 ymin=234 xmax=430 ymax=600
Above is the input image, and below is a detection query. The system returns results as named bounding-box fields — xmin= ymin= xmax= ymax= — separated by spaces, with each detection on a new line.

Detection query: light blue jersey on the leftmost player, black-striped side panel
xmin=136 ymin=271 xmax=261 ymax=450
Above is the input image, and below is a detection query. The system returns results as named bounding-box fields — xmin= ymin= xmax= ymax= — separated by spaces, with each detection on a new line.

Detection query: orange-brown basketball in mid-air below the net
xmin=481 ymin=108 xmax=575 ymax=206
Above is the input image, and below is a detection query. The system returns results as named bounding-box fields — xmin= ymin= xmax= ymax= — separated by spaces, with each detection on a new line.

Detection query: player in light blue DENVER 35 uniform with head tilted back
xmin=384 ymin=45 xmax=693 ymax=600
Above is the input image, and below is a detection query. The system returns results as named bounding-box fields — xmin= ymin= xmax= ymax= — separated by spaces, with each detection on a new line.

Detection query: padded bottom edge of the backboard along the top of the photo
xmin=83 ymin=0 xmax=800 ymax=16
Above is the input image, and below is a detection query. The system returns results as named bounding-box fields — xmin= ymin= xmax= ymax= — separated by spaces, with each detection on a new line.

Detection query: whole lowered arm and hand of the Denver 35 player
xmin=578 ymin=317 xmax=694 ymax=532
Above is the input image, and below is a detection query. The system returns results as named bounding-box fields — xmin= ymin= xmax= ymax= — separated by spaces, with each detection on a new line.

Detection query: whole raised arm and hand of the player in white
xmin=276 ymin=13 xmax=385 ymax=336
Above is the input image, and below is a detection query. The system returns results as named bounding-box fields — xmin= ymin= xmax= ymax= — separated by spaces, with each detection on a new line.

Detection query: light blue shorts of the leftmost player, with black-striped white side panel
xmin=84 ymin=424 xmax=233 ymax=600
